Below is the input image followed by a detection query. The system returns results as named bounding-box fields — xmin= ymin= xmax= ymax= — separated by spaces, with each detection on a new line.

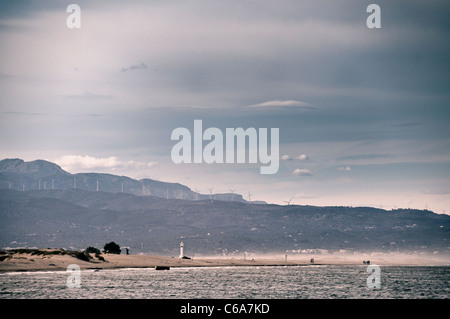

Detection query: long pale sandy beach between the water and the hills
xmin=0 ymin=249 xmax=450 ymax=273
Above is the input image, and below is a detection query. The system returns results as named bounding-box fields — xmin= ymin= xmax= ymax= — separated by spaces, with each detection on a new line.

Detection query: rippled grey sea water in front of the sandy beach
xmin=0 ymin=265 xmax=450 ymax=299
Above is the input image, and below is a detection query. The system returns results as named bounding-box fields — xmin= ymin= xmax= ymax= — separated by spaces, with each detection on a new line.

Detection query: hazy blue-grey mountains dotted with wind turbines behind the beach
xmin=0 ymin=159 xmax=450 ymax=256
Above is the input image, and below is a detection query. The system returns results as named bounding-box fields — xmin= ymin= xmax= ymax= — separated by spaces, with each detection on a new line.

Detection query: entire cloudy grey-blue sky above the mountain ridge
xmin=0 ymin=0 xmax=450 ymax=214
